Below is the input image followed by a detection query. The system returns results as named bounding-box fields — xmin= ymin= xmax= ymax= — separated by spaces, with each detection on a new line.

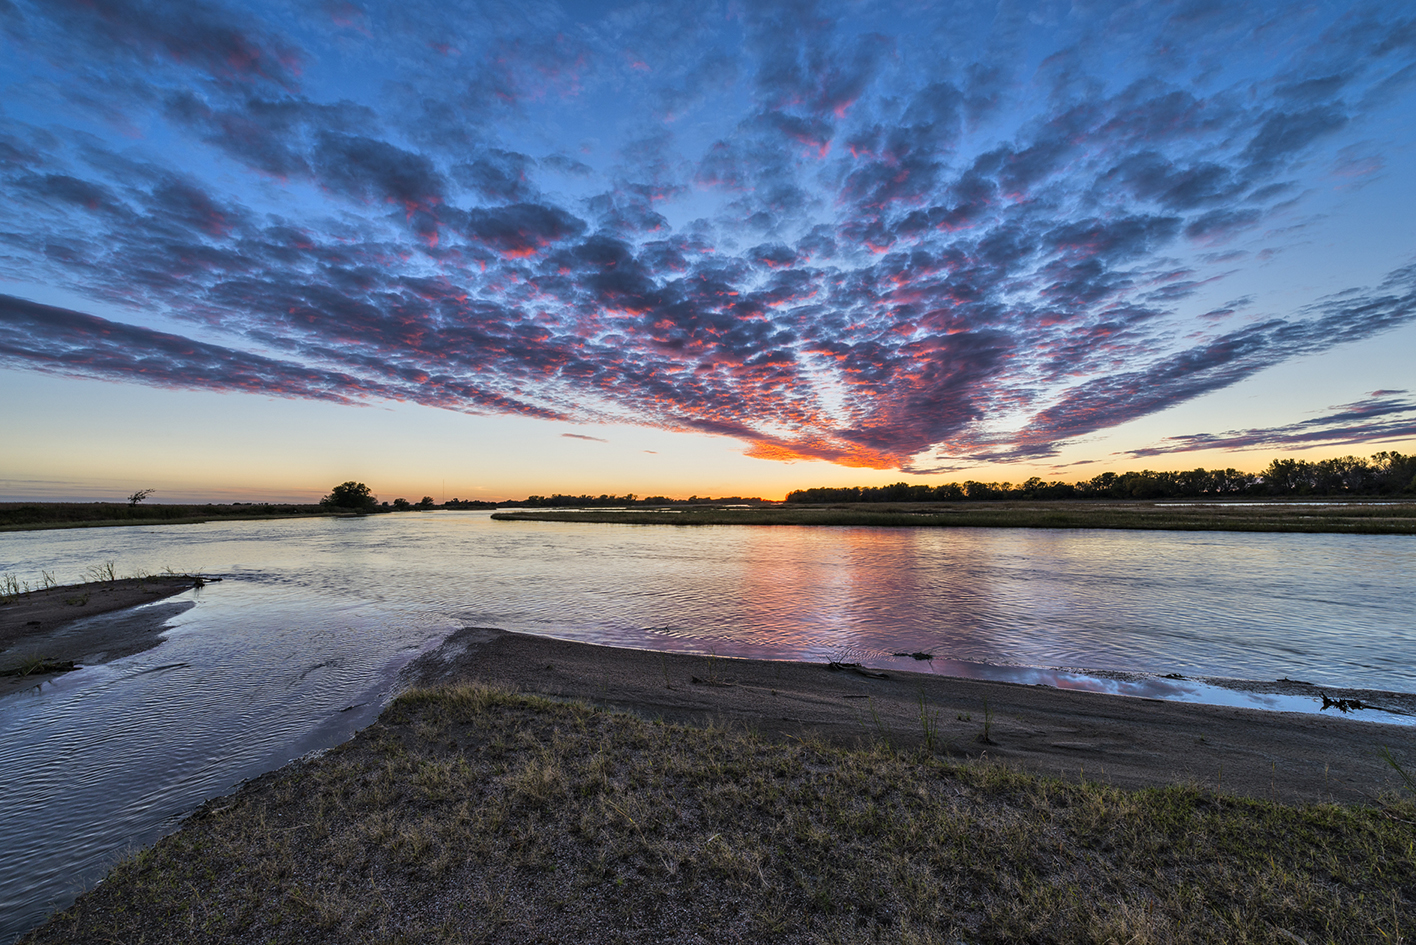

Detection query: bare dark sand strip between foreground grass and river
xmin=405 ymin=628 xmax=1416 ymax=803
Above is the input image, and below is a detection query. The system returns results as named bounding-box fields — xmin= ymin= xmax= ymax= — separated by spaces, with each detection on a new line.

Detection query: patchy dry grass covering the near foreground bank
xmin=23 ymin=684 xmax=1416 ymax=945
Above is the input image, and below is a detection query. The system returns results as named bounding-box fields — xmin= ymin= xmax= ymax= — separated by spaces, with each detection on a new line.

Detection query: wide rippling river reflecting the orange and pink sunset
xmin=0 ymin=511 xmax=1416 ymax=944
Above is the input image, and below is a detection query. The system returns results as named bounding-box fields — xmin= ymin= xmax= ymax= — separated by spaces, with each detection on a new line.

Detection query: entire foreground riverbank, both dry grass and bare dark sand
xmin=24 ymin=629 xmax=1416 ymax=944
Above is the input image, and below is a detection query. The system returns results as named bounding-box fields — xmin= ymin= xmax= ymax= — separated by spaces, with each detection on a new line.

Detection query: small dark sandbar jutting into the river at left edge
xmin=0 ymin=574 xmax=205 ymax=697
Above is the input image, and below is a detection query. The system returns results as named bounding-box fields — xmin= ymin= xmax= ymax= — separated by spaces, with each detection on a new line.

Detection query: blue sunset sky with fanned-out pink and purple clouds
xmin=0 ymin=0 xmax=1416 ymax=502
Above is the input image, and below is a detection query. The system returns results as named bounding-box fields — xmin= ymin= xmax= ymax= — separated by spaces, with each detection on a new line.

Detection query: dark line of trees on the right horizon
xmin=787 ymin=451 xmax=1416 ymax=503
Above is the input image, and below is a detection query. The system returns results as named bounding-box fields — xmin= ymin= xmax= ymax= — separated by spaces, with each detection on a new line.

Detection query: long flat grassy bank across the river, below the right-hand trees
xmin=491 ymin=500 xmax=1416 ymax=534
